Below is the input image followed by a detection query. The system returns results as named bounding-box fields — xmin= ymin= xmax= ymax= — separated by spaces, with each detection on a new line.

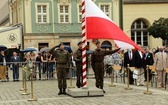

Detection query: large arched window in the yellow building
xmin=131 ymin=19 xmax=148 ymax=46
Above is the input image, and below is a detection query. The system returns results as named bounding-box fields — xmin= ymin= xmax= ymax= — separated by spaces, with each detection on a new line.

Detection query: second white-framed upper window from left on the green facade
xmin=60 ymin=5 xmax=69 ymax=23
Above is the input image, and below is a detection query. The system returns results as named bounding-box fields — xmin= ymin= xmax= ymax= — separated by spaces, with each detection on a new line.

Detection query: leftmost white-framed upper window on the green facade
xmin=37 ymin=5 xmax=47 ymax=23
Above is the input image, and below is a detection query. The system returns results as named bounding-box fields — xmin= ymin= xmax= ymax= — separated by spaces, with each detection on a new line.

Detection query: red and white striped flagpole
xmin=82 ymin=0 xmax=87 ymax=87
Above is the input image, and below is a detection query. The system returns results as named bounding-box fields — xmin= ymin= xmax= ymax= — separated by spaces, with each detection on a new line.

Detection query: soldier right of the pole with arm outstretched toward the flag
xmin=91 ymin=41 xmax=120 ymax=93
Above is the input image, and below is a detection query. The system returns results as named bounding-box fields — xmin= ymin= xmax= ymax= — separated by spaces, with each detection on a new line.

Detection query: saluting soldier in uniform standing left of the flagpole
xmin=50 ymin=43 xmax=70 ymax=95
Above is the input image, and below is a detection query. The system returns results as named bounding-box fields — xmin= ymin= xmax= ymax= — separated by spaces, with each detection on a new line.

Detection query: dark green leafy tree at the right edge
xmin=148 ymin=18 xmax=168 ymax=45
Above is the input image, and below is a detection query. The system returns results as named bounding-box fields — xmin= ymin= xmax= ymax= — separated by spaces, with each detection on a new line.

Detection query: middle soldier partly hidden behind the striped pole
xmin=74 ymin=41 xmax=83 ymax=88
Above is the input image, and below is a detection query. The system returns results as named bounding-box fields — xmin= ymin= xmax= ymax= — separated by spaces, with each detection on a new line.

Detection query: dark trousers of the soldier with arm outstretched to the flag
xmin=95 ymin=69 xmax=104 ymax=88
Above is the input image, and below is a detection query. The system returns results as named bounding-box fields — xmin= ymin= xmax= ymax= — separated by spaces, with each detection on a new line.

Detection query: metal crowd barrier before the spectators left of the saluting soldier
xmin=0 ymin=62 xmax=57 ymax=81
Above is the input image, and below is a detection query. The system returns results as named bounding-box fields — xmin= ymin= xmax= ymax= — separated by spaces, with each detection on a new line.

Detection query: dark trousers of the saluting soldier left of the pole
xmin=57 ymin=68 xmax=67 ymax=89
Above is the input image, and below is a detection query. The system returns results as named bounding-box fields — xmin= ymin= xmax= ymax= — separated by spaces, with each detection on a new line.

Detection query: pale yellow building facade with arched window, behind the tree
xmin=123 ymin=0 xmax=168 ymax=48
